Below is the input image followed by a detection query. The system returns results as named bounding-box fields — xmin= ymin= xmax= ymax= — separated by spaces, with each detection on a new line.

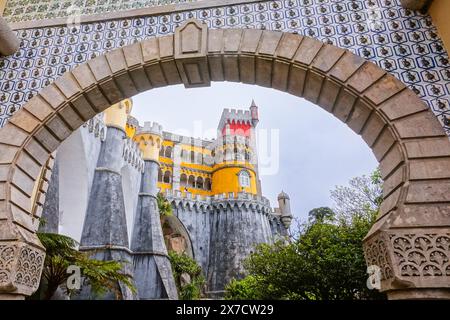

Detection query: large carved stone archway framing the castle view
xmin=0 ymin=20 xmax=450 ymax=299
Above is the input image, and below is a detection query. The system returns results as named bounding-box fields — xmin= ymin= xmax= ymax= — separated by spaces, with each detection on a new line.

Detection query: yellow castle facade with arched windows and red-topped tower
xmin=121 ymin=99 xmax=258 ymax=197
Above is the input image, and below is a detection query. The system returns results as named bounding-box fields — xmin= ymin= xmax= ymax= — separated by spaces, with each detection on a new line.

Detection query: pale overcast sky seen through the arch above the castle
xmin=132 ymin=82 xmax=377 ymax=219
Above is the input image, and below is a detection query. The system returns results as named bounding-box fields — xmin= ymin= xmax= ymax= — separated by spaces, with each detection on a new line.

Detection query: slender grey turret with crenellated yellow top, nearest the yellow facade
xmin=131 ymin=122 xmax=178 ymax=299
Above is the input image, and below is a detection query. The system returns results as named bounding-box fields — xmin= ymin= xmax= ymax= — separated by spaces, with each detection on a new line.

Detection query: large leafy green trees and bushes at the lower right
xmin=225 ymin=172 xmax=384 ymax=300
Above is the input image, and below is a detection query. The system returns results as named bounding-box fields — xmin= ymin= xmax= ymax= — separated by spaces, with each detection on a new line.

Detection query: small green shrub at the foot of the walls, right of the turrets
xmin=169 ymin=251 xmax=205 ymax=300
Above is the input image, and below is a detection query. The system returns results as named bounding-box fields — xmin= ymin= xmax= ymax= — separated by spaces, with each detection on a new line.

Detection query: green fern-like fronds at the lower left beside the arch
xmin=34 ymin=232 xmax=136 ymax=300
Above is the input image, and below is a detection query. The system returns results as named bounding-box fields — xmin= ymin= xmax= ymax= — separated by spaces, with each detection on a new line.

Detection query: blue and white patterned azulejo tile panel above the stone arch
xmin=0 ymin=0 xmax=450 ymax=135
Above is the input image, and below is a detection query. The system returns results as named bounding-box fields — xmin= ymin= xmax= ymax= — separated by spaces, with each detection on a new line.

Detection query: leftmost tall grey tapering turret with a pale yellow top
xmin=79 ymin=100 xmax=134 ymax=299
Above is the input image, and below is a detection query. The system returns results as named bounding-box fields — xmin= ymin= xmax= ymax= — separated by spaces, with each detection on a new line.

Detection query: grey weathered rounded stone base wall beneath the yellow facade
xmin=174 ymin=201 xmax=276 ymax=292
